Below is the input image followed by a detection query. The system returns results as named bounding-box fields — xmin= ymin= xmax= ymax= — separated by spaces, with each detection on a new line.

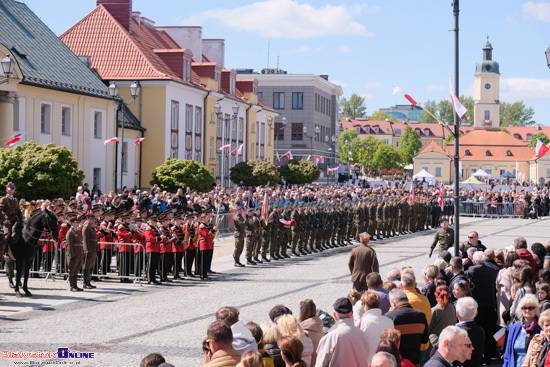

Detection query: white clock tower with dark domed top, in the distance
xmin=474 ymin=37 xmax=500 ymax=130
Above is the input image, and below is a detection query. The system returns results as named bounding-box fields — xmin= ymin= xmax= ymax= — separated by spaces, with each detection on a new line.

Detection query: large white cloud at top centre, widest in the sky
xmin=184 ymin=0 xmax=379 ymax=38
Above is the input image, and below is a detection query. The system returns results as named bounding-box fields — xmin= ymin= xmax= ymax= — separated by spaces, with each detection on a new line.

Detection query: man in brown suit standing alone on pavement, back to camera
xmin=348 ymin=232 xmax=379 ymax=292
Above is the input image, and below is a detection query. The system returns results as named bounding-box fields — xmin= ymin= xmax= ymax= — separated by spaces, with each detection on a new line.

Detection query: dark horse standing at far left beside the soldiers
xmin=8 ymin=210 xmax=59 ymax=298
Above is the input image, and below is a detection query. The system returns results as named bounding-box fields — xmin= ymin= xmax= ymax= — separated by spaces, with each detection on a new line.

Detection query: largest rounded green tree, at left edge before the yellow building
xmin=0 ymin=141 xmax=84 ymax=200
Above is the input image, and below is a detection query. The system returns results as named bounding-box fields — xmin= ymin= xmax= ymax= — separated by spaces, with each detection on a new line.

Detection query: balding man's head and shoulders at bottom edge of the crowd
xmin=424 ymin=326 xmax=472 ymax=367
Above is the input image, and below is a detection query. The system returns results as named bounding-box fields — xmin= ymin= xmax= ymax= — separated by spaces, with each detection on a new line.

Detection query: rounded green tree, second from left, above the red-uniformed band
xmin=150 ymin=158 xmax=214 ymax=192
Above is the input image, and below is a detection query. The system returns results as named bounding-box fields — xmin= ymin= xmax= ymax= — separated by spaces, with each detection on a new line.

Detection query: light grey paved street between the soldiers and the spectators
xmin=0 ymin=218 xmax=549 ymax=367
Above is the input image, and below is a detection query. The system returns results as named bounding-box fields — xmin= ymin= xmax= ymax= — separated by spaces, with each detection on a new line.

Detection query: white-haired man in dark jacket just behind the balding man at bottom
xmin=456 ymin=297 xmax=485 ymax=367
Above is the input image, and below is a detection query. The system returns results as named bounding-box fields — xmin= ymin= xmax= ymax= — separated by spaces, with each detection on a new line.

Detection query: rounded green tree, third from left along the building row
xmin=229 ymin=159 xmax=280 ymax=186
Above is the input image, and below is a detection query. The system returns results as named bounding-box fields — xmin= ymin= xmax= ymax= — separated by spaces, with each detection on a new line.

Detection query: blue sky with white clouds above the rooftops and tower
xmin=22 ymin=0 xmax=550 ymax=125
